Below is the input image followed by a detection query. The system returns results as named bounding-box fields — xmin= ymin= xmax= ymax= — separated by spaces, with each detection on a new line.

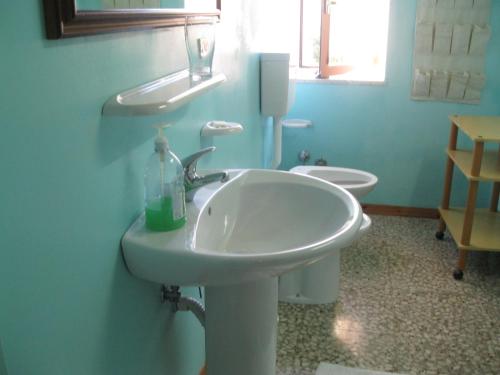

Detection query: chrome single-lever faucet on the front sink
xmin=181 ymin=146 xmax=229 ymax=202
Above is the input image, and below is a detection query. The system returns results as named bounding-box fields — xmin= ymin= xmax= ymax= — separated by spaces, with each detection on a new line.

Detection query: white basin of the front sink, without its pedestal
xmin=123 ymin=170 xmax=362 ymax=286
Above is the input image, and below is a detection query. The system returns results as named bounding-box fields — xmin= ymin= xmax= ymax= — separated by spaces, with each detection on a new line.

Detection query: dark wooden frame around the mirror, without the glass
xmin=43 ymin=0 xmax=222 ymax=39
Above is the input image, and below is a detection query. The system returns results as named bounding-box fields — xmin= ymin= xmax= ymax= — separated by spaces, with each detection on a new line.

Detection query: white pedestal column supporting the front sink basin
xmin=205 ymin=277 xmax=278 ymax=375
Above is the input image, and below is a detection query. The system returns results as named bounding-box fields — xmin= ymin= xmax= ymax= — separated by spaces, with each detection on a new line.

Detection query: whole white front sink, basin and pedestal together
xmin=122 ymin=170 xmax=370 ymax=375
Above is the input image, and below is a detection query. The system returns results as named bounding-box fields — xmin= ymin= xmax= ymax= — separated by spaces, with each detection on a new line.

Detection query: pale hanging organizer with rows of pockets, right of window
xmin=411 ymin=0 xmax=491 ymax=104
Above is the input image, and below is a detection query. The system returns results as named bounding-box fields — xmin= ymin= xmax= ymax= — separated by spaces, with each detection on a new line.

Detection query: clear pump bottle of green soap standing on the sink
xmin=144 ymin=125 xmax=186 ymax=232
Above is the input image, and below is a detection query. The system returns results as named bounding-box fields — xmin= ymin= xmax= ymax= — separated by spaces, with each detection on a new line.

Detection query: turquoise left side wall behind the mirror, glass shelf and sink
xmin=0 ymin=0 xmax=262 ymax=375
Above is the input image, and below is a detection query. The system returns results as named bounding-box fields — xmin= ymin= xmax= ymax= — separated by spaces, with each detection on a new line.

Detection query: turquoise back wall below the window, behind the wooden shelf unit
xmin=282 ymin=0 xmax=500 ymax=207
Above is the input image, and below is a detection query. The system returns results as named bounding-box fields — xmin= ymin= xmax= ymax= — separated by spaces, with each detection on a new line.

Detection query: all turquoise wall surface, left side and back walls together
xmin=0 ymin=0 xmax=500 ymax=375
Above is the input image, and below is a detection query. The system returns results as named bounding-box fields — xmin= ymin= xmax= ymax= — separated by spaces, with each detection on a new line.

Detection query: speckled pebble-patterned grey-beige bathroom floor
xmin=277 ymin=216 xmax=500 ymax=375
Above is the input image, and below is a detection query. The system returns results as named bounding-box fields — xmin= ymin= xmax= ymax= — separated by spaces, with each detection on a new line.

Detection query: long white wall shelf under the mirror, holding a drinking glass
xmin=102 ymin=70 xmax=226 ymax=116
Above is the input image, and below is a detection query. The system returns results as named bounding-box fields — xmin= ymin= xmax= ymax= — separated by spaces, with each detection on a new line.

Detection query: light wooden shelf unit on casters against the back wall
xmin=436 ymin=116 xmax=500 ymax=279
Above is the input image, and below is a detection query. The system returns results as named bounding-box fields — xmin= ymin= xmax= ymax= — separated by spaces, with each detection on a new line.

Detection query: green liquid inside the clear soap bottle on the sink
xmin=146 ymin=197 xmax=186 ymax=232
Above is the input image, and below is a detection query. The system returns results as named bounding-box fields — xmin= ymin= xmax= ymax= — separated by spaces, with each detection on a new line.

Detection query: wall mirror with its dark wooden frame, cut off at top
xmin=43 ymin=0 xmax=221 ymax=39
